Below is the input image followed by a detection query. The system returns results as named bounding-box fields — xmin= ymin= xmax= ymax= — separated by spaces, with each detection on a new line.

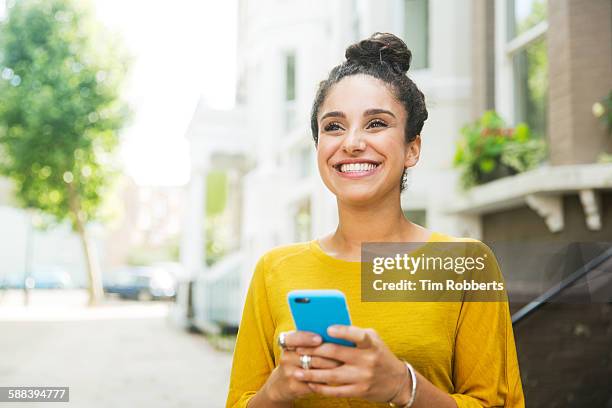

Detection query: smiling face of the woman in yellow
xmin=317 ymin=75 xmax=421 ymax=204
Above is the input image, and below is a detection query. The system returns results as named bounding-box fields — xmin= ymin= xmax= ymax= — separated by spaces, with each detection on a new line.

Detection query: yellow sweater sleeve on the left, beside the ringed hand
xmin=226 ymin=256 xmax=274 ymax=408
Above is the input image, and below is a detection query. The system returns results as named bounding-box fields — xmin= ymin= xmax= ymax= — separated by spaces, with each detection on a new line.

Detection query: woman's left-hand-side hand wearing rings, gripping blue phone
xmin=264 ymin=331 xmax=341 ymax=403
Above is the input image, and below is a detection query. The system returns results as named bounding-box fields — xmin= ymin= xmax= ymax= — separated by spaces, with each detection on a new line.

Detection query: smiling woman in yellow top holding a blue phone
xmin=227 ymin=33 xmax=524 ymax=408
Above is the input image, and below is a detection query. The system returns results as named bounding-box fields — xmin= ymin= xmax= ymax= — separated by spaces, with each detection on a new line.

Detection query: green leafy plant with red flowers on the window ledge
xmin=453 ymin=111 xmax=546 ymax=188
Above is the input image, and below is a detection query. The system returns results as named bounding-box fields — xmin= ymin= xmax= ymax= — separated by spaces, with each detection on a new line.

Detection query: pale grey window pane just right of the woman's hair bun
xmin=404 ymin=0 xmax=429 ymax=69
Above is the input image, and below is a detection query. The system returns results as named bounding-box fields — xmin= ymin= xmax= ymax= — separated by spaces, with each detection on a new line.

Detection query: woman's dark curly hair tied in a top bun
xmin=310 ymin=33 xmax=427 ymax=190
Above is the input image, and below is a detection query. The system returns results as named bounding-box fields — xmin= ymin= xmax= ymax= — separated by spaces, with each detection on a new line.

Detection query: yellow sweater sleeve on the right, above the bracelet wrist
xmin=451 ymin=243 xmax=525 ymax=408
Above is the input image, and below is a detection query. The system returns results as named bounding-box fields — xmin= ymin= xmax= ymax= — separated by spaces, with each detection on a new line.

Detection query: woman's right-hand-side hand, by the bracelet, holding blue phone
xmin=294 ymin=325 xmax=411 ymax=402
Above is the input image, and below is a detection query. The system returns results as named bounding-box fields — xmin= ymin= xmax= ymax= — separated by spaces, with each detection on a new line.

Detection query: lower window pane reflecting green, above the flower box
xmin=514 ymin=38 xmax=548 ymax=136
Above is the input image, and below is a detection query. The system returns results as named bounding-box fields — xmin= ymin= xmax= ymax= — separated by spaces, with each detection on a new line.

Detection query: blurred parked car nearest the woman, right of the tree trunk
xmin=104 ymin=266 xmax=176 ymax=300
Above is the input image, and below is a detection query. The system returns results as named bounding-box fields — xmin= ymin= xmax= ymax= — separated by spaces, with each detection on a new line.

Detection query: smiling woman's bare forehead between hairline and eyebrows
xmin=319 ymin=75 xmax=404 ymax=118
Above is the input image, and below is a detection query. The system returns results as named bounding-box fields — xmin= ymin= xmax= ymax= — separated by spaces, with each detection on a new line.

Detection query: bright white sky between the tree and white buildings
xmin=94 ymin=0 xmax=237 ymax=185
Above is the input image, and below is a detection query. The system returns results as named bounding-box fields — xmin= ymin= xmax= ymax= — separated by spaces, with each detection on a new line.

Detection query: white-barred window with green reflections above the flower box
xmin=506 ymin=0 xmax=548 ymax=136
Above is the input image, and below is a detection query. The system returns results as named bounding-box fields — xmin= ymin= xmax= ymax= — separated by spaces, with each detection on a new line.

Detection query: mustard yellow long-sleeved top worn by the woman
xmin=226 ymin=232 xmax=525 ymax=408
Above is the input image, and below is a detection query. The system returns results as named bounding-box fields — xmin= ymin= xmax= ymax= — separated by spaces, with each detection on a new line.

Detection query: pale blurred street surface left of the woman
xmin=0 ymin=294 xmax=231 ymax=408
